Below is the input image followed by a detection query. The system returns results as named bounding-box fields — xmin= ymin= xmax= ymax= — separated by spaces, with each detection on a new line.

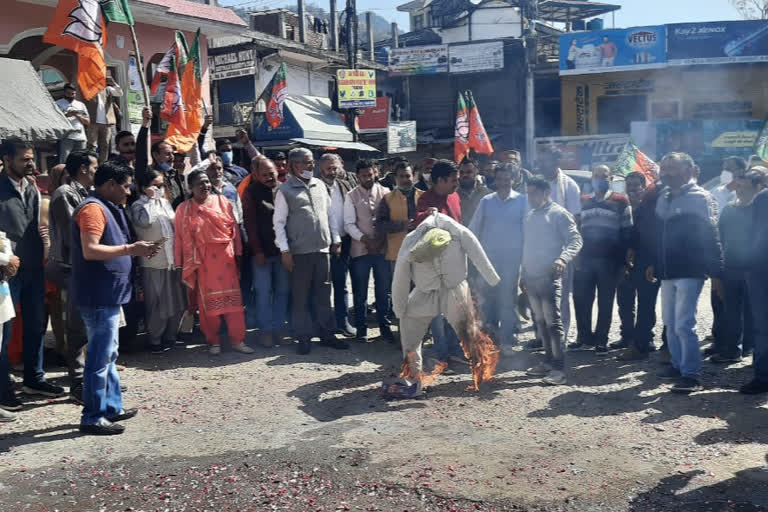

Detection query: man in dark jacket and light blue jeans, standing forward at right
xmin=647 ymin=153 xmax=723 ymax=393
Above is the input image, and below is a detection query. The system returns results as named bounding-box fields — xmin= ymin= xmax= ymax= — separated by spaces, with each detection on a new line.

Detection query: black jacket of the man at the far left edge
xmin=0 ymin=172 xmax=43 ymax=271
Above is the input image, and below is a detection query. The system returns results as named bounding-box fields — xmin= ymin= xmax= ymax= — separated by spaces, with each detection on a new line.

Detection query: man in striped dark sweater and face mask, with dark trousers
xmin=570 ymin=165 xmax=632 ymax=355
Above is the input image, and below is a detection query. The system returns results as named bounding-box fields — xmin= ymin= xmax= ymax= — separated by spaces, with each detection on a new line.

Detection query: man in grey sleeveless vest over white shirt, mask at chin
xmin=272 ymin=148 xmax=349 ymax=355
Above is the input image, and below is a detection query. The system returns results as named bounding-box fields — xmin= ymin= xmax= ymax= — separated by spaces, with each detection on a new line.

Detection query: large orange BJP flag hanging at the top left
xmin=43 ymin=0 xmax=107 ymax=100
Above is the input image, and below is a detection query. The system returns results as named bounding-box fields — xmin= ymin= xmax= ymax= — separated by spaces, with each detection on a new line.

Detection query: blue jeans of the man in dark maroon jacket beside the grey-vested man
xmin=251 ymin=256 xmax=291 ymax=329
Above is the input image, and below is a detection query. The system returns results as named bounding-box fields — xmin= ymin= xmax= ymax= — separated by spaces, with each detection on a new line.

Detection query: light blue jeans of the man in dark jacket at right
xmin=661 ymin=279 xmax=704 ymax=378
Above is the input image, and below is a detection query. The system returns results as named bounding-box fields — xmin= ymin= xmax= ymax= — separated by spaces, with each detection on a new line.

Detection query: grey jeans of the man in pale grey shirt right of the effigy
xmin=525 ymin=277 xmax=565 ymax=370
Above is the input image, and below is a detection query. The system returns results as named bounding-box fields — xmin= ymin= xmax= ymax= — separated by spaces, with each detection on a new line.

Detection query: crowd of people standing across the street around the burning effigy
xmin=0 ymin=84 xmax=768 ymax=435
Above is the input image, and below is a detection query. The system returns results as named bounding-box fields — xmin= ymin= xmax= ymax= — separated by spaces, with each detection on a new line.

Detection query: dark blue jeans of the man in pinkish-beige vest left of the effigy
xmin=349 ymin=254 xmax=392 ymax=335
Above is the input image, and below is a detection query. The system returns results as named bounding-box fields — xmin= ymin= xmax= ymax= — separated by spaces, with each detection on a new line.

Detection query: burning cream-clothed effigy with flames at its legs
xmin=383 ymin=213 xmax=500 ymax=397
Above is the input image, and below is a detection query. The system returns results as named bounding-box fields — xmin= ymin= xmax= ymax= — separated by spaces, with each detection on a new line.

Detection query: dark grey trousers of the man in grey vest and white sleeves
xmin=291 ymin=252 xmax=335 ymax=341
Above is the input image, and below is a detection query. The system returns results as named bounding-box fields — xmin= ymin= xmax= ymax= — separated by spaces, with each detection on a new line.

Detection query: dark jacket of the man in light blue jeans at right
xmin=656 ymin=183 xmax=723 ymax=279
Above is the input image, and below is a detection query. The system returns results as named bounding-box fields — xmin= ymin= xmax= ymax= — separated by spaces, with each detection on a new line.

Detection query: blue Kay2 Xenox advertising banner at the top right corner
xmin=667 ymin=20 xmax=768 ymax=66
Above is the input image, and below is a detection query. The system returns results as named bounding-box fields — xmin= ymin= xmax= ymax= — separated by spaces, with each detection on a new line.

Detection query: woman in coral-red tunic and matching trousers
xmin=174 ymin=171 xmax=254 ymax=355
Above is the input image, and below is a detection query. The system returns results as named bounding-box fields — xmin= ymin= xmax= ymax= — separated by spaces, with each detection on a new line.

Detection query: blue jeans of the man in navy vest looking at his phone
xmin=80 ymin=306 xmax=123 ymax=425
